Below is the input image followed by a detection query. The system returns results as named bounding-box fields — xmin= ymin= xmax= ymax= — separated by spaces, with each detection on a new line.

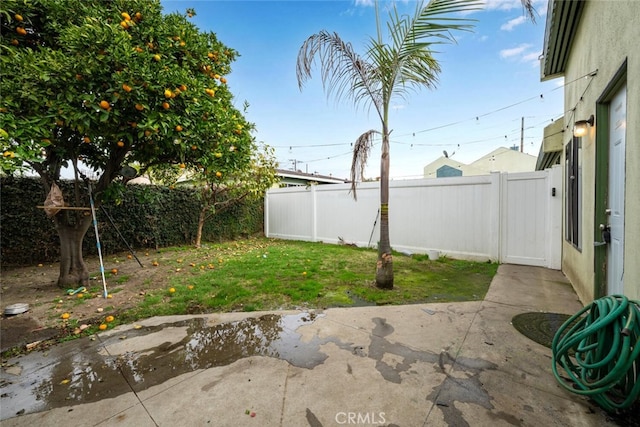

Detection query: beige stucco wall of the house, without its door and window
xmin=562 ymin=0 xmax=640 ymax=304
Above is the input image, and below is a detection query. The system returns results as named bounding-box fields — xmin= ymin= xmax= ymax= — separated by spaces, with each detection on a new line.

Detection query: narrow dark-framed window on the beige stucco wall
xmin=564 ymin=137 xmax=582 ymax=249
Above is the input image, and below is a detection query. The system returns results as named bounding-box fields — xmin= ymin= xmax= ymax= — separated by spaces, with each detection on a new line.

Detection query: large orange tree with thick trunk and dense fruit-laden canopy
xmin=0 ymin=0 xmax=254 ymax=287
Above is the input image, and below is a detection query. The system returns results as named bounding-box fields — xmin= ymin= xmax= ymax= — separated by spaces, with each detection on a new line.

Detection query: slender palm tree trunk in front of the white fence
xmin=376 ymin=132 xmax=393 ymax=289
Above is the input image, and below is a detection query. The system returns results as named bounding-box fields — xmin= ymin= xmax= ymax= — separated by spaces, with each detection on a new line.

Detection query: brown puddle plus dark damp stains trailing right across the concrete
xmin=0 ymin=313 xmax=504 ymax=426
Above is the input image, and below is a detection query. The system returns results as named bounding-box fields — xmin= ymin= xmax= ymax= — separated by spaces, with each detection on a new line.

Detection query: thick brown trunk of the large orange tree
xmin=54 ymin=216 xmax=91 ymax=288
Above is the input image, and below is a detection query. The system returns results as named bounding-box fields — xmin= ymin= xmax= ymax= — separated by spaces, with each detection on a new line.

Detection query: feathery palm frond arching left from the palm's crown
xmin=296 ymin=30 xmax=381 ymax=120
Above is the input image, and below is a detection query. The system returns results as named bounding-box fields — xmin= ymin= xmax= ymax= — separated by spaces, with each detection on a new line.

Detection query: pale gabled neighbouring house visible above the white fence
xmin=423 ymin=147 xmax=536 ymax=178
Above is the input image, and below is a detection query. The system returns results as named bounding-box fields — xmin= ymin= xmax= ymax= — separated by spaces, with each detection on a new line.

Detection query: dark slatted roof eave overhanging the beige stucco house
xmin=540 ymin=0 xmax=585 ymax=81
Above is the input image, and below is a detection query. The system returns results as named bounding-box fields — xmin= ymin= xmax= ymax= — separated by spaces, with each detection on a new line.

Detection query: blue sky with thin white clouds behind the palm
xmin=162 ymin=0 xmax=563 ymax=179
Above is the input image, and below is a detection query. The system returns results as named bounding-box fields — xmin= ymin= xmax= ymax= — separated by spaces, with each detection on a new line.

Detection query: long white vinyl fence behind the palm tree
xmin=265 ymin=167 xmax=562 ymax=269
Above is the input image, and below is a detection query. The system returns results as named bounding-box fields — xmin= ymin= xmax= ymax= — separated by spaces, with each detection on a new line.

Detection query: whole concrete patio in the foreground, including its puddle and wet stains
xmin=0 ymin=265 xmax=617 ymax=427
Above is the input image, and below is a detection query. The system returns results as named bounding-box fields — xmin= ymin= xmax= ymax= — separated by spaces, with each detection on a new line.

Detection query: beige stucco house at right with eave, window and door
xmin=539 ymin=0 xmax=640 ymax=304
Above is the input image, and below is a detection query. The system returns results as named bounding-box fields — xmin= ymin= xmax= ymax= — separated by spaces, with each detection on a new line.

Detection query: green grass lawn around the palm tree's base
xmin=119 ymin=238 xmax=498 ymax=322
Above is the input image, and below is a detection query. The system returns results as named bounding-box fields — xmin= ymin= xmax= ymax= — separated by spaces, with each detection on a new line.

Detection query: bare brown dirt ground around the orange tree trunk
xmin=0 ymin=249 xmax=188 ymax=352
